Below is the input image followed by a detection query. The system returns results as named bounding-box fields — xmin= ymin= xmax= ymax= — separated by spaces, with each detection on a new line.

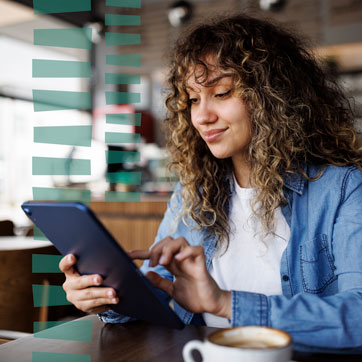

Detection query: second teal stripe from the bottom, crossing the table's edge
xmin=34 ymin=321 xmax=93 ymax=342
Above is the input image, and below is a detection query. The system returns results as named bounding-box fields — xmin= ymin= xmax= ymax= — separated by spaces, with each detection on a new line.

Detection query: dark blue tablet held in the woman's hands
xmin=21 ymin=202 xmax=184 ymax=329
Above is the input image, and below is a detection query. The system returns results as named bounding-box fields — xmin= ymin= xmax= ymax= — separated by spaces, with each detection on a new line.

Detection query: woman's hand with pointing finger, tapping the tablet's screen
xmin=129 ymin=237 xmax=231 ymax=319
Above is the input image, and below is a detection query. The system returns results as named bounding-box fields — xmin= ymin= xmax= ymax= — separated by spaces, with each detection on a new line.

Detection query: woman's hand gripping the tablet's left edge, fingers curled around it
xmin=59 ymin=254 xmax=119 ymax=313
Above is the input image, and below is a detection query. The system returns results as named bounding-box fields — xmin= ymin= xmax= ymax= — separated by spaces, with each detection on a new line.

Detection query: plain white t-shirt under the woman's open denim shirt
xmin=203 ymin=177 xmax=290 ymax=328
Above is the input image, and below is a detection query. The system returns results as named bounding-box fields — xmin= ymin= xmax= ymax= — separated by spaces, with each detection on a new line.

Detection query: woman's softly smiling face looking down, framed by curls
xmin=187 ymin=61 xmax=251 ymax=160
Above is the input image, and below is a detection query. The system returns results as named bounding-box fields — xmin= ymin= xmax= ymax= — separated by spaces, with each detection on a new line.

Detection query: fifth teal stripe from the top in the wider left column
xmin=34 ymin=126 xmax=92 ymax=147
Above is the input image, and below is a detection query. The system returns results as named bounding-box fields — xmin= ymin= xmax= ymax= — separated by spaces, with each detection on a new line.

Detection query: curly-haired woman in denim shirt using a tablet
xmin=60 ymin=15 xmax=362 ymax=350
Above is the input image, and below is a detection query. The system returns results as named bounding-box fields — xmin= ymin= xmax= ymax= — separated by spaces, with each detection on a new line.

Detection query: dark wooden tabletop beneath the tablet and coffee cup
xmin=0 ymin=315 xmax=361 ymax=362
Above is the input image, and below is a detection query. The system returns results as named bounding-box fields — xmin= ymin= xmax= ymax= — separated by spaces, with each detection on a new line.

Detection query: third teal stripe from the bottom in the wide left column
xmin=33 ymin=284 xmax=72 ymax=307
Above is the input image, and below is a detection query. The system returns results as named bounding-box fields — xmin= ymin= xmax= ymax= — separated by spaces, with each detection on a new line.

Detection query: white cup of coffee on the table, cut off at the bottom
xmin=182 ymin=326 xmax=293 ymax=362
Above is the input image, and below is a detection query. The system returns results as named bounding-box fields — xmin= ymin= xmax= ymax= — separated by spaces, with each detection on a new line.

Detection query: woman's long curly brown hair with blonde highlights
xmin=163 ymin=14 xmax=362 ymax=246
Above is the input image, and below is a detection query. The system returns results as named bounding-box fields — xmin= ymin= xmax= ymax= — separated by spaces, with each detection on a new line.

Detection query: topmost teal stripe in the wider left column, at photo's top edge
xmin=33 ymin=0 xmax=92 ymax=14
